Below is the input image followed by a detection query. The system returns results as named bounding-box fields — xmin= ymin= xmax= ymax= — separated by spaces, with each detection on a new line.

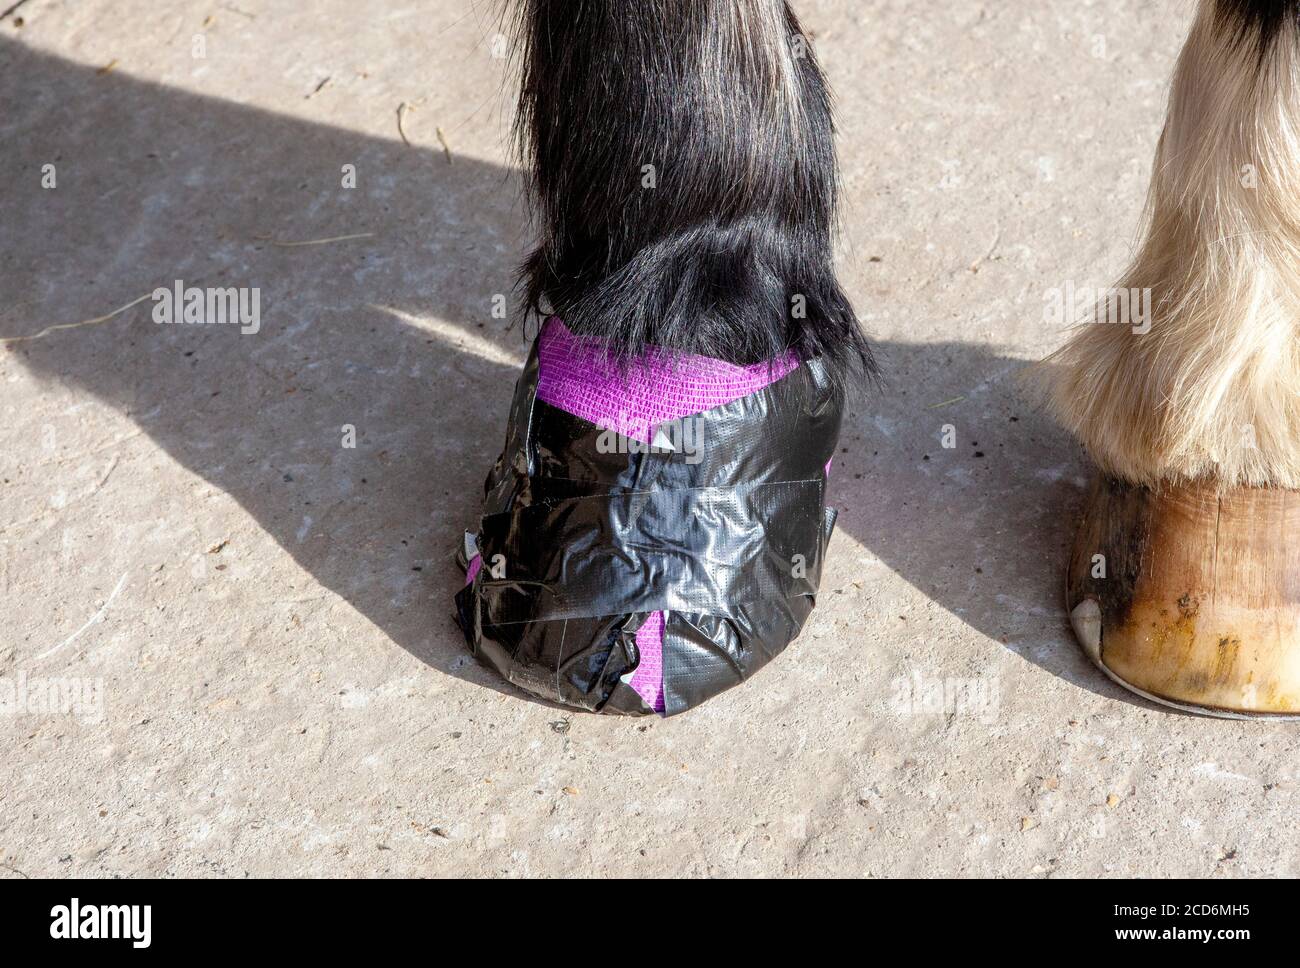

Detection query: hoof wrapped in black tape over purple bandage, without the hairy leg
xmin=456 ymin=318 xmax=844 ymax=715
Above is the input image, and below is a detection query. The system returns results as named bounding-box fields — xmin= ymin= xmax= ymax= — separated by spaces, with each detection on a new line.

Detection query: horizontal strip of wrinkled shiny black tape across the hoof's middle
xmin=478 ymin=481 xmax=823 ymax=625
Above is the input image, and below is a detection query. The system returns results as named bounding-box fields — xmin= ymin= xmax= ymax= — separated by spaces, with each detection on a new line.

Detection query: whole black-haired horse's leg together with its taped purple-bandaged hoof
xmin=458 ymin=0 xmax=871 ymax=713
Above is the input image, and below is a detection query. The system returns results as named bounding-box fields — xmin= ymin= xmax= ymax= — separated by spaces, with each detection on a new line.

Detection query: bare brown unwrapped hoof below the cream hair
xmin=1066 ymin=478 xmax=1300 ymax=719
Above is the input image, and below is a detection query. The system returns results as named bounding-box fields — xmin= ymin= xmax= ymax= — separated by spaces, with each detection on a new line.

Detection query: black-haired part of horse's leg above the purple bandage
xmin=519 ymin=0 xmax=870 ymax=364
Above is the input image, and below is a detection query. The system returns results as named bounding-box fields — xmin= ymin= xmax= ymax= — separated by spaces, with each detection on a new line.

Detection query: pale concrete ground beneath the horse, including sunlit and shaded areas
xmin=0 ymin=0 xmax=1300 ymax=877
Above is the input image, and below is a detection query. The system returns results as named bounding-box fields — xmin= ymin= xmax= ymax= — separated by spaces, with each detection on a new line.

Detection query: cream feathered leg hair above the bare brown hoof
xmin=1052 ymin=0 xmax=1300 ymax=489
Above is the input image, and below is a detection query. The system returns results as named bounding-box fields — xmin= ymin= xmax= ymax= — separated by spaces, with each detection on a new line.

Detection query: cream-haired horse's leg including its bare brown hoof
xmin=1054 ymin=0 xmax=1300 ymax=715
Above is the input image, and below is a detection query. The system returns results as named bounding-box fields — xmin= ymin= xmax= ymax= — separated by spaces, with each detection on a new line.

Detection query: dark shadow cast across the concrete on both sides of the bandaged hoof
xmin=0 ymin=42 xmax=1121 ymax=695
